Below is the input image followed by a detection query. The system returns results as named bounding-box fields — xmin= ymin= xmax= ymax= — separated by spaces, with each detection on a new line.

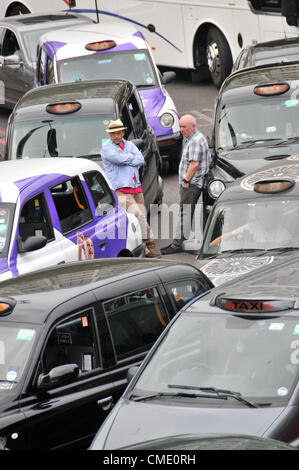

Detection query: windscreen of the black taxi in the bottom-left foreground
xmin=0 ymin=320 xmax=37 ymax=395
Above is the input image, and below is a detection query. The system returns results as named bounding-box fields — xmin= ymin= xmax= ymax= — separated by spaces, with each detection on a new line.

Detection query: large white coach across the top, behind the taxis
xmin=0 ymin=0 xmax=299 ymax=87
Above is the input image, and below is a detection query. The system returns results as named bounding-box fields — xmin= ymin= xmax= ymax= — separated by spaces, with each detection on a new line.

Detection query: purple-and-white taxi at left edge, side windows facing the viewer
xmin=0 ymin=158 xmax=144 ymax=281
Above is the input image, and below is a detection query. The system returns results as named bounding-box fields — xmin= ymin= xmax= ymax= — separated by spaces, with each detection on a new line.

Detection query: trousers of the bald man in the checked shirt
xmin=172 ymin=184 xmax=202 ymax=246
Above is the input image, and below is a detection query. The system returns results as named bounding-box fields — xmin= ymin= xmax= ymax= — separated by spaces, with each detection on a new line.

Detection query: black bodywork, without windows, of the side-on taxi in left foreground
xmin=0 ymin=258 xmax=212 ymax=449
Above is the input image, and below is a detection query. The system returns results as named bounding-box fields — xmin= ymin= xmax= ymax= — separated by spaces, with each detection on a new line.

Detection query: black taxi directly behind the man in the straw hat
xmin=4 ymin=80 xmax=163 ymax=208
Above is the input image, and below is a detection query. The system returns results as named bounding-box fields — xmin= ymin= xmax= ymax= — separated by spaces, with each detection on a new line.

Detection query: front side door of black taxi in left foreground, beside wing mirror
xmin=20 ymin=300 xmax=114 ymax=450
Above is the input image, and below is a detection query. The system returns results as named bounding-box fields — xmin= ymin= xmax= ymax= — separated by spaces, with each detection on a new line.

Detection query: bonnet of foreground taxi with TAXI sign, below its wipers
xmin=92 ymin=398 xmax=284 ymax=449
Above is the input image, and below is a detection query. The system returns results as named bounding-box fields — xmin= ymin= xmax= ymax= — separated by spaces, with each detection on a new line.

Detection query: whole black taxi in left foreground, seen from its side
xmin=0 ymin=258 xmax=213 ymax=450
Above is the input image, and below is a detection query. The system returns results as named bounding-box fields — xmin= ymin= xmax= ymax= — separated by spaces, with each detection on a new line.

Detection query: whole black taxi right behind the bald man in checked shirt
xmin=203 ymin=63 xmax=299 ymax=222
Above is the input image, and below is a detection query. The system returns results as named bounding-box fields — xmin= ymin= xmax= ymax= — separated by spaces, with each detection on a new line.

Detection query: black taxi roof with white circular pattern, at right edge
xmin=217 ymin=155 xmax=299 ymax=202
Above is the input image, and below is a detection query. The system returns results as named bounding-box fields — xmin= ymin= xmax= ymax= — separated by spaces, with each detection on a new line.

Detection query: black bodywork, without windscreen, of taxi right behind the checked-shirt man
xmin=203 ymin=63 xmax=299 ymax=220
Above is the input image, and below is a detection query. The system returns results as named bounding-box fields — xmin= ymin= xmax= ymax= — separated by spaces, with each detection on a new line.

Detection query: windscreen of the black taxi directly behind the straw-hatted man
xmin=10 ymin=114 xmax=114 ymax=160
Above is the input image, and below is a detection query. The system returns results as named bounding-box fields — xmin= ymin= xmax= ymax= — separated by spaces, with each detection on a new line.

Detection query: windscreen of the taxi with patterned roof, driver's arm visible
xmin=202 ymin=196 xmax=299 ymax=257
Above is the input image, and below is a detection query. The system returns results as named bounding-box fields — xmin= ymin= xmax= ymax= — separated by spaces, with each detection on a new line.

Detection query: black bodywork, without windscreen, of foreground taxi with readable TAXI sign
xmin=90 ymin=256 xmax=299 ymax=450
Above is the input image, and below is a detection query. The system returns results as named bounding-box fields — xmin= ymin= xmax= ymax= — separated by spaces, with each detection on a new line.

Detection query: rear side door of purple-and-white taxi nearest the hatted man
xmin=50 ymin=172 xmax=126 ymax=262
